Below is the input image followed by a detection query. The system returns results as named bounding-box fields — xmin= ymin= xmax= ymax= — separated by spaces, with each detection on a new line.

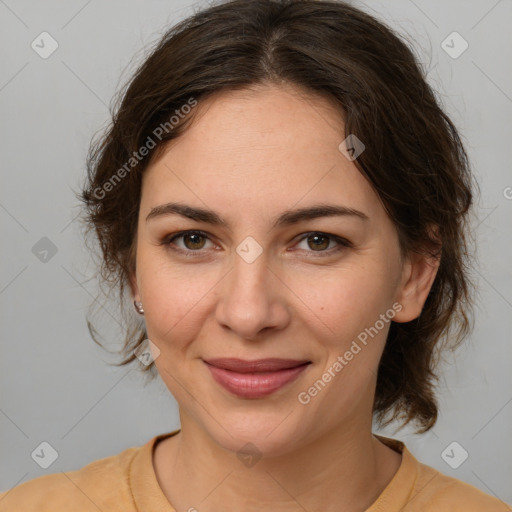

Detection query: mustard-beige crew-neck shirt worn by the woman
xmin=0 ymin=430 xmax=512 ymax=512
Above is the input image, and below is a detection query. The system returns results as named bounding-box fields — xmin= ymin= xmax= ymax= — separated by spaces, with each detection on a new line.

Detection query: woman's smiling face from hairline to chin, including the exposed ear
xmin=132 ymin=86 xmax=433 ymax=454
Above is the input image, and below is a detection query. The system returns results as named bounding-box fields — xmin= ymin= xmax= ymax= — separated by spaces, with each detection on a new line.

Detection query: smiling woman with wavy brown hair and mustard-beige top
xmin=0 ymin=0 xmax=510 ymax=512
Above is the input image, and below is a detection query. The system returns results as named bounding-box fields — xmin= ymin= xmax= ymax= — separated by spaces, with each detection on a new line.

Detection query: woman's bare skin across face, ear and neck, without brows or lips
xmin=131 ymin=85 xmax=438 ymax=512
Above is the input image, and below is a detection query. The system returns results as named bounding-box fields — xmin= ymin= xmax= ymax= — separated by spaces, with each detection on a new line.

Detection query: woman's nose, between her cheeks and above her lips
xmin=216 ymin=248 xmax=290 ymax=340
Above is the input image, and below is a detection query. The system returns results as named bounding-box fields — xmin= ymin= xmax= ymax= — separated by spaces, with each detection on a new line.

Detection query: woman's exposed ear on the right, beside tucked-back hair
xmin=393 ymin=246 xmax=441 ymax=323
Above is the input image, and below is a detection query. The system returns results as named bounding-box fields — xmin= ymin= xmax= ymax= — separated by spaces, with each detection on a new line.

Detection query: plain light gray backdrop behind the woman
xmin=0 ymin=0 xmax=512 ymax=503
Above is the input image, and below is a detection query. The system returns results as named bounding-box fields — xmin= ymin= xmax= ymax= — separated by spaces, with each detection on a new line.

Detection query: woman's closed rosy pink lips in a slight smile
xmin=204 ymin=358 xmax=311 ymax=398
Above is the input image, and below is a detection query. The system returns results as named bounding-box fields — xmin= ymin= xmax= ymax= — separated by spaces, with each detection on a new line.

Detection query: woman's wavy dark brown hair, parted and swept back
xmin=79 ymin=0 xmax=473 ymax=432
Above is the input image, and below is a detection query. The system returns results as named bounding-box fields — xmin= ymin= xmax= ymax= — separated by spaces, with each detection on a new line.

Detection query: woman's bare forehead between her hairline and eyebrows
xmin=141 ymin=86 xmax=382 ymax=222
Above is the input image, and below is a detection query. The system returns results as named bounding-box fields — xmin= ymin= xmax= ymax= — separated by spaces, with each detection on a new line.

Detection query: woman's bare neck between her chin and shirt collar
xmin=155 ymin=413 xmax=401 ymax=512
